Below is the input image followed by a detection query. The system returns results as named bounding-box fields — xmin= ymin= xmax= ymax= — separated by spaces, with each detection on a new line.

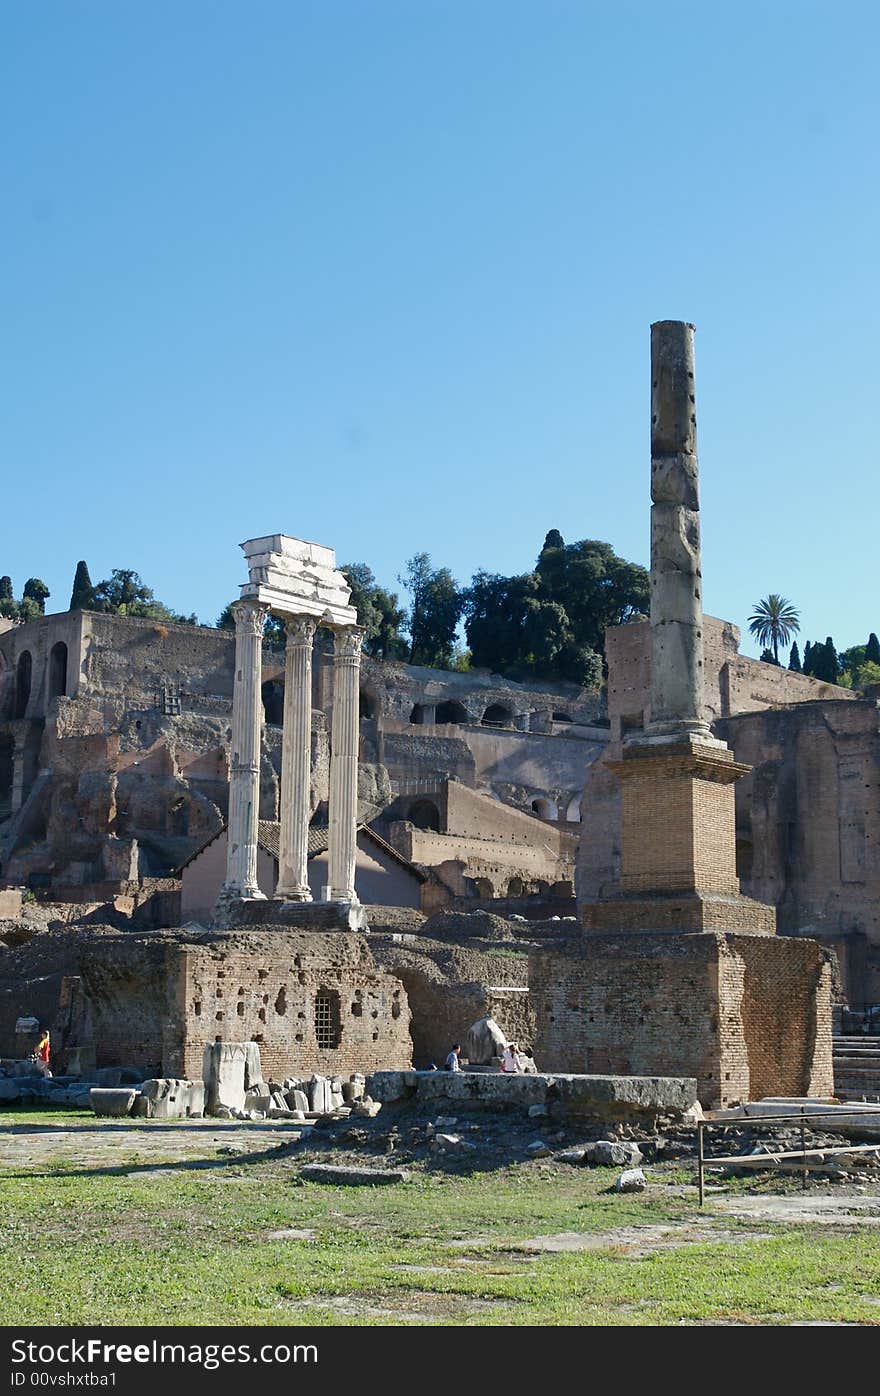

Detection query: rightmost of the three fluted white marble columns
xmin=328 ymin=625 xmax=363 ymax=902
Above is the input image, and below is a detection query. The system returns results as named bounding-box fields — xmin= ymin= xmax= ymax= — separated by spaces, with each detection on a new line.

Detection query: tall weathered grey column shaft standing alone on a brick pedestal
xmin=648 ymin=320 xmax=710 ymax=736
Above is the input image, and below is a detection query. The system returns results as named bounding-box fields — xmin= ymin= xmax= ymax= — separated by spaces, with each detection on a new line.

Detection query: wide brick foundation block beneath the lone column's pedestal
xmin=529 ymin=931 xmax=834 ymax=1107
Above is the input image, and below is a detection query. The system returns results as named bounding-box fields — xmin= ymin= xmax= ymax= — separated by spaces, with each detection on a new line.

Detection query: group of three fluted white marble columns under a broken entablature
xmin=222 ymin=600 xmax=363 ymax=903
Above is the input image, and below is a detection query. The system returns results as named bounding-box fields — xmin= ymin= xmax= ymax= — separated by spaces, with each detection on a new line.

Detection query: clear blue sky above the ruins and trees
xmin=0 ymin=0 xmax=880 ymax=652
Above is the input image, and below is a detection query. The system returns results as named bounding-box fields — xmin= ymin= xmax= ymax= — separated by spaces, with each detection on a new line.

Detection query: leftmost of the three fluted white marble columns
xmin=221 ymin=602 xmax=268 ymax=899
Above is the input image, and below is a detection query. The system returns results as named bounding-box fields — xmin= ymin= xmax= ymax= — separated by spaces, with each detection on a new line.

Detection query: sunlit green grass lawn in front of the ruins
xmin=0 ymin=1111 xmax=880 ymax=1325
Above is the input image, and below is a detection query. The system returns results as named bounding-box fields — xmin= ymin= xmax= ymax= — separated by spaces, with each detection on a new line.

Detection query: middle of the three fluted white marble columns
xmin=275 ymin=616 xmax=316 ymax=902
